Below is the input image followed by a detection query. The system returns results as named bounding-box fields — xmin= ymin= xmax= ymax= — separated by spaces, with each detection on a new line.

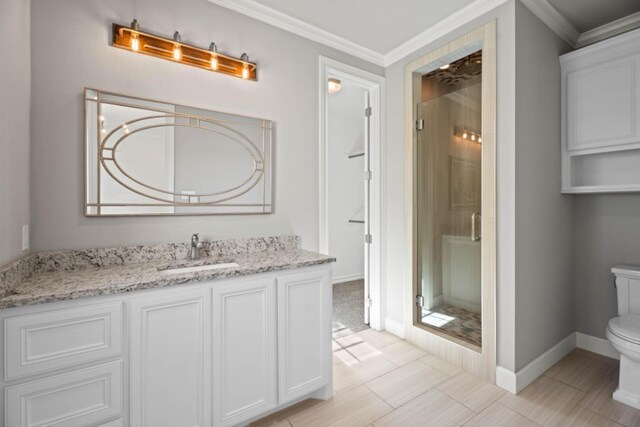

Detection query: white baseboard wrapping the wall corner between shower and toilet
xmin=496 ymin=332 xmax=576 ymax=394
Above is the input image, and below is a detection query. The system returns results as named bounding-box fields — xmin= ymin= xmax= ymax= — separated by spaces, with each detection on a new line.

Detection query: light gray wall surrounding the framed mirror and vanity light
xmin=28 ymin=0 xmax=383 ymax=250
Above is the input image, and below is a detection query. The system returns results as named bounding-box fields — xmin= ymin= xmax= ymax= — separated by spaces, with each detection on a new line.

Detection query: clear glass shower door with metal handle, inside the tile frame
xmin=416 ymin=51 xmax=482 ymax=349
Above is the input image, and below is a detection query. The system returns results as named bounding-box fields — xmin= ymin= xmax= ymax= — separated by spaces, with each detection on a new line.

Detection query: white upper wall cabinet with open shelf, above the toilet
xmin=560 ymin=30 xmax=640 ymax=193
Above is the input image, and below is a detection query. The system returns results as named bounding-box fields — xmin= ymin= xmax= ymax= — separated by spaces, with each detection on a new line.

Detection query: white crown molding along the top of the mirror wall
xmin=209 ymin=0 xmax=385 ymax=66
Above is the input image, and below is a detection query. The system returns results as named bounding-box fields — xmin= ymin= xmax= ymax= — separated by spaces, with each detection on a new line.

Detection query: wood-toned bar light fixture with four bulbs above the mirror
xmin=113 ymin=19 xmax=257 ymax=81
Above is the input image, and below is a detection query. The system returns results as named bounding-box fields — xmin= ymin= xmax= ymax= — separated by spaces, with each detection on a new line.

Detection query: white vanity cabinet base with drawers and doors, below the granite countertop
xmin=0 ymin=264 xmax=332 ymax=427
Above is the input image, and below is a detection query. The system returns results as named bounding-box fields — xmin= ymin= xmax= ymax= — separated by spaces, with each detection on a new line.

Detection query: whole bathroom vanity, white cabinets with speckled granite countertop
xmin=0 ymin=236 xmax=334 ymax=427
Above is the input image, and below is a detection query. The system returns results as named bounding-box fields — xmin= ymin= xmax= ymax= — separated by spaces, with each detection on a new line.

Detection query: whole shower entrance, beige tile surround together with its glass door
xmin=404 ymin=21 xmax=497 ymax=381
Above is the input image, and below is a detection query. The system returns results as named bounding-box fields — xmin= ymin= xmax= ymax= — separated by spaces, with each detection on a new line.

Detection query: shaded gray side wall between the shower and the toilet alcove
xmin=515 ymin=2 xmax=574 ymax=371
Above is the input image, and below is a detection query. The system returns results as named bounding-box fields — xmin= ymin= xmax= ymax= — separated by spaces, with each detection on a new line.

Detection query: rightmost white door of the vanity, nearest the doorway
xmin=278 ymin=269 xmax=331 ymax=404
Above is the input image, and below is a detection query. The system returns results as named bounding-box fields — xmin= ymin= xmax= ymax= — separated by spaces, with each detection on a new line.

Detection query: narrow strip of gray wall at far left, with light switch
xmin=0 ymin=0 xmax=31 ymax=265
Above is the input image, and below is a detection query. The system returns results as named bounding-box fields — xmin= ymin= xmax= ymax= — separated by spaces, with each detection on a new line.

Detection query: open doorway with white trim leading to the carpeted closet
xmin=319 ymin=57 xmax=384 ymax=337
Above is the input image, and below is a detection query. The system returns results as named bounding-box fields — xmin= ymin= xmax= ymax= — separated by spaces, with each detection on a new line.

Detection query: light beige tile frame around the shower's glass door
xmin=404 ymin=21 xmax=497 ymax=382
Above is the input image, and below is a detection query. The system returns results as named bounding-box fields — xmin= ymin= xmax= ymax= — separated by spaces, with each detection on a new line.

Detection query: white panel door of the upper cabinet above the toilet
xmin=567 ymin=58 xmax=640 ymax=151
